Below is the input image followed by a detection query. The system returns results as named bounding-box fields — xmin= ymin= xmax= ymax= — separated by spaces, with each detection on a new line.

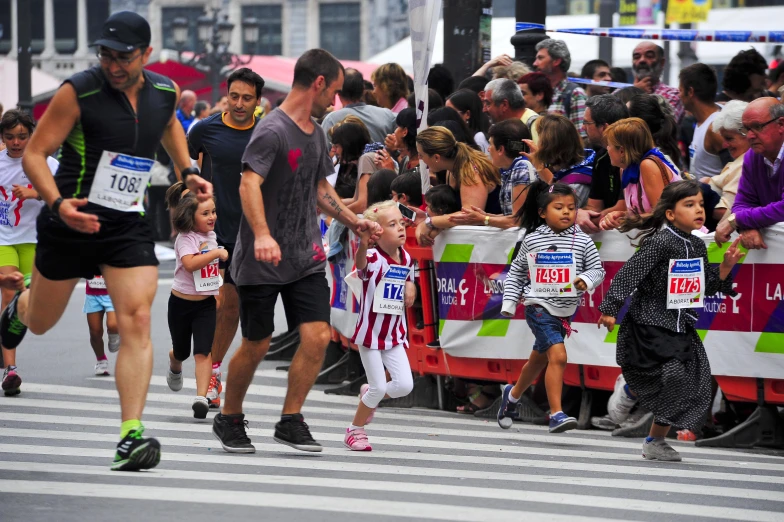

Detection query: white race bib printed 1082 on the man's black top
xmin=87 ymin=150 xmax=155 ymax=212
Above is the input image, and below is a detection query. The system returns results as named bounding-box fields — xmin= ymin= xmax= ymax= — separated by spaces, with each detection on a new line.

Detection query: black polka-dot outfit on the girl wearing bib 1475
xmin=599 ymin=225 xmax=736 ymax=430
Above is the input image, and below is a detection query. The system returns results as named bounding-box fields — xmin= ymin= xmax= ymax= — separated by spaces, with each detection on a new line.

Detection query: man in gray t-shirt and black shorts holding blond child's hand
xmin=212 ymin=49 xmax=381 ymax=453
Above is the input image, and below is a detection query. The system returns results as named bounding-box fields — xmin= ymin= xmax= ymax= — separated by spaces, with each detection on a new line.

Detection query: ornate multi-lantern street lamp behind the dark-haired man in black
xmin=172 ymin=8 xmax=259 ymax=104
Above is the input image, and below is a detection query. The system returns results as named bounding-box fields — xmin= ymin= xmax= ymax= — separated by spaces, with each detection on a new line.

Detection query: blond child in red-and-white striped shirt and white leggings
xmin=343 ymin=201 xmax=416 ymax=451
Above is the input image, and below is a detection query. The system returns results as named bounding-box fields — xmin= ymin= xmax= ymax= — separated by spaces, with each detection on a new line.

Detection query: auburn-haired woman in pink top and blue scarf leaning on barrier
xmin=600 ymin=118 xmax=681 ymax=230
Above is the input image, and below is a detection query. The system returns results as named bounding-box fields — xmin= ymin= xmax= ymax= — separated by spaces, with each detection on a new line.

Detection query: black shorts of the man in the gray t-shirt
xmin=237 ymin=272 xmax=330 ymax=341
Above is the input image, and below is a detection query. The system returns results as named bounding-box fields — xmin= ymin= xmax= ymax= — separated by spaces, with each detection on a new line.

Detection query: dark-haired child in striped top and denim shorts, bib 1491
xmin=497 ymin=180 xmax=605 ymax=433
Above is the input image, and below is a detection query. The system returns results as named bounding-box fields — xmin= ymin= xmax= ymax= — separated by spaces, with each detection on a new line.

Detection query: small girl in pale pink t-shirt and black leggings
xmin=166 ymin=182 xmax=229 ymax=419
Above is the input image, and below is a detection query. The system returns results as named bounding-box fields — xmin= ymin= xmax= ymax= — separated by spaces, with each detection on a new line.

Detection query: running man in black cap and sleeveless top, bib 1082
xmin=0 ymin=12 xmax=212 ymax=471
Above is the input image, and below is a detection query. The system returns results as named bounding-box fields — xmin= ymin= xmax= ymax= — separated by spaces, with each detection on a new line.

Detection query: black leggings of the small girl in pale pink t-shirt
xmin=169 ymin=294 xmax=216 ymax=361
